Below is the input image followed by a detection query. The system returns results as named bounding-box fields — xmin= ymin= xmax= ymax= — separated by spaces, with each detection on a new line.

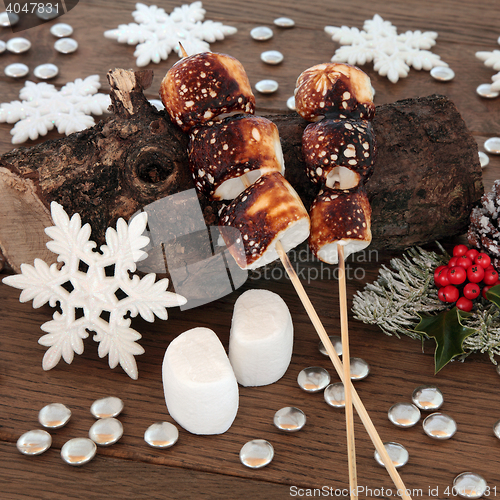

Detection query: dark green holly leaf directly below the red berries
xmin=415 ymin=306 xmax=474 ymax=374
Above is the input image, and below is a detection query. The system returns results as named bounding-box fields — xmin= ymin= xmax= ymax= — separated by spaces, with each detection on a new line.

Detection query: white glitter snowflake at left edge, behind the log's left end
xmin=0 ymin=75 xmax=111 ymax=144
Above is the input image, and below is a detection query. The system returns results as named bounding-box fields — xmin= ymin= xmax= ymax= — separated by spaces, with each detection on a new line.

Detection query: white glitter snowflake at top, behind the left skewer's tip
xmin=104 ymin=2 xmax=237 ymax=67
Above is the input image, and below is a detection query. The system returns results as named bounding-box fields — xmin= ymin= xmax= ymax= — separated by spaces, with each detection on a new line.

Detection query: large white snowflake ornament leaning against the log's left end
xmin=3 ymin=202 xmax=186 ymax=379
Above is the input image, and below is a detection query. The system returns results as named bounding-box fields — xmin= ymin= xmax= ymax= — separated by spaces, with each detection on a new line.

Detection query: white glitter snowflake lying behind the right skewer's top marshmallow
xmin=325 ymin=14 xmax=448 ymax=83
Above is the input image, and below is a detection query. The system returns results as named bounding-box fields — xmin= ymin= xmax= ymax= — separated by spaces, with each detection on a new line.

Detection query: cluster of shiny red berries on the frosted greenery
xmin=434 ymin=245 xmax=500 ymax=312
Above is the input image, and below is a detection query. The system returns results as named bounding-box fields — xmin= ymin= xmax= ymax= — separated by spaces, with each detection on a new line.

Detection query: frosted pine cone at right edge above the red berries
xmin=467 ymin=180 xmax=500 ymax=269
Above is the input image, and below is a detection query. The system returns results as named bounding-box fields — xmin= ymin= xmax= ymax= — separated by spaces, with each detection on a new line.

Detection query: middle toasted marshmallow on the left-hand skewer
xmin=189 ymin=116 xmax=285 ymax=200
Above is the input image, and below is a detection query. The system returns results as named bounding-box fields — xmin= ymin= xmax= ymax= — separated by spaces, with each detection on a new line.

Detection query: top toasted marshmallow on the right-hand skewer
xmin=295 ymin=63 xmax=375 ymax=122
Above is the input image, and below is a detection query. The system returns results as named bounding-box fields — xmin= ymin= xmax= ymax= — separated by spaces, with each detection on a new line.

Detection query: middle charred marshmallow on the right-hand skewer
xmin=302 ymin=118 xmax=376 ymax=189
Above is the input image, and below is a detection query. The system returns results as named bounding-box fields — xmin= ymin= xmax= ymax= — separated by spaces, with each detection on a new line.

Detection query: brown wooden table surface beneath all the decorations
xmin=0 ymin=0 xmax=500 ymax=500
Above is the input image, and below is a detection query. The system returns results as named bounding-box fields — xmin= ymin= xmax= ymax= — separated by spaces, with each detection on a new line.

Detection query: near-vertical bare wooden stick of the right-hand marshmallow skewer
xmin=337 ymin=243 xmax=358 ymax=500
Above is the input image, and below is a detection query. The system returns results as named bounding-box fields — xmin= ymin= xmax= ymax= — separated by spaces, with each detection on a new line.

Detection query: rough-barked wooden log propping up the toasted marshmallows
xmin=0 ymin=69 xmax=483 ymax=271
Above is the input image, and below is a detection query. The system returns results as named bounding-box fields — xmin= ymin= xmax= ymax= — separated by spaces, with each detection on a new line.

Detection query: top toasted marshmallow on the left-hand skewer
xmin=160 ymin=52 xmax=255 ymax=132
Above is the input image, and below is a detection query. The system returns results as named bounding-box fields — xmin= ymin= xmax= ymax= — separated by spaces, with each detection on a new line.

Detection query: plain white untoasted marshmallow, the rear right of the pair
xmin=229 ymin=290 xmax=293 ymax=387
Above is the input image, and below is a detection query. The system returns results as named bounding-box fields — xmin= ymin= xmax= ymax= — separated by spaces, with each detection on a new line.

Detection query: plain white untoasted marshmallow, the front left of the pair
xmin=162 ymin=327 xmax=238 ymax=434
